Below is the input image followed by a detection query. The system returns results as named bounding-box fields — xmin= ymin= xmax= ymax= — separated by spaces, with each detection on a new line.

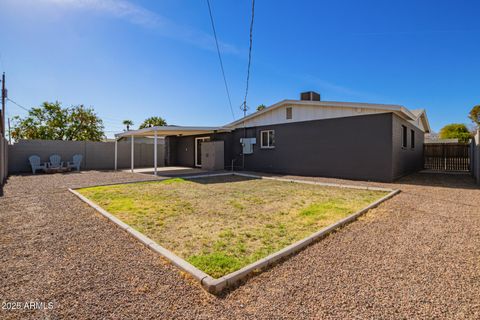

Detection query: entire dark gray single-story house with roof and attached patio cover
xmin=117 ymin=92 xmax=430 ymax=181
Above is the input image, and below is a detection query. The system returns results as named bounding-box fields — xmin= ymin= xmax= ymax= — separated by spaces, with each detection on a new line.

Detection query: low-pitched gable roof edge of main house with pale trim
xmin=224 ymin=100 xmax=430 ymax=132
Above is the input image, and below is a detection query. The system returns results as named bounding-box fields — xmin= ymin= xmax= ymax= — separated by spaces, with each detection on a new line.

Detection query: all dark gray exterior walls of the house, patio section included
xmin=167 ymin=113 xmax=423 ymax=181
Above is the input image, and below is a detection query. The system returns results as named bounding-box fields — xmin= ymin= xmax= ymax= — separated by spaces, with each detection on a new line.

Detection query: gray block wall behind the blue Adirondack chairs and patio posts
xmin=8 ymin=140 xmax=165 ymax=173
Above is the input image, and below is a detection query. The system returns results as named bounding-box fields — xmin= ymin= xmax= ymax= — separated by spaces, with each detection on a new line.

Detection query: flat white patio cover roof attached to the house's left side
xmin=115 ymin=126 xmax=230 ymax=139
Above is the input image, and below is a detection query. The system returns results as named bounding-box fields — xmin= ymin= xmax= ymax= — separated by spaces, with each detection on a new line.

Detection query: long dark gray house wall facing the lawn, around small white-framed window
xmin=235 ymin=114 xmax=392 ymax=181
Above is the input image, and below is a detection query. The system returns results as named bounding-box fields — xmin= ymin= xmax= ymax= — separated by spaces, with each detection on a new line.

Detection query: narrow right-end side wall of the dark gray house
xmin=392 ymin=114 xmax=425 ymax=180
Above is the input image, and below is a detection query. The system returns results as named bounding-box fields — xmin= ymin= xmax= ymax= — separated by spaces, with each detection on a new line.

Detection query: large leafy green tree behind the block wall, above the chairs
xmin=12 ymin=101 xmax=105 ymax=141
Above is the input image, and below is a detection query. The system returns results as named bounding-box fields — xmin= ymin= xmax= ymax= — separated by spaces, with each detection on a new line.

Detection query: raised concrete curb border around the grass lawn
xmin=68 ymin=172 xmax=400 ymax=294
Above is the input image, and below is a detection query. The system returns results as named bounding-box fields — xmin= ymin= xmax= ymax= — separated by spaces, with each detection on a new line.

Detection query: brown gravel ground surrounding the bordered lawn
xmin=0 ymin=171 xmax=480 ymax=319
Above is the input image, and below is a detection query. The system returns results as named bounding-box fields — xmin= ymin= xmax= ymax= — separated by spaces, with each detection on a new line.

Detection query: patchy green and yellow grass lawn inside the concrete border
xmin=78 ymin=176 xmax=386 ymax=278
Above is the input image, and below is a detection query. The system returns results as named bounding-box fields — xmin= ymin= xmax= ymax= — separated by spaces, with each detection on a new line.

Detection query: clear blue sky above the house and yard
xmin=0 ymin=0 xmax=480 ymax=136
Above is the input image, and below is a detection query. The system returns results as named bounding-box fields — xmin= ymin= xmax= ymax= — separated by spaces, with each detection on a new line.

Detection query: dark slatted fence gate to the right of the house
xmin=423 ymin=143 xmax=470 ymax=171
